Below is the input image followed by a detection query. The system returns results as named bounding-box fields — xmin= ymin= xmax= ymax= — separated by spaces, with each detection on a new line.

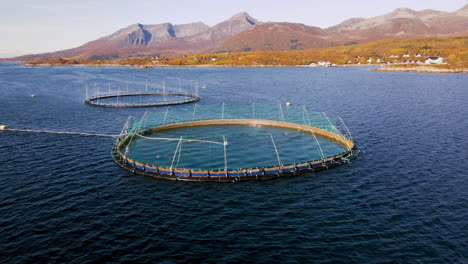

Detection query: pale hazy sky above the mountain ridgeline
xmin=0 ymin=0 xmax=468 ymax=57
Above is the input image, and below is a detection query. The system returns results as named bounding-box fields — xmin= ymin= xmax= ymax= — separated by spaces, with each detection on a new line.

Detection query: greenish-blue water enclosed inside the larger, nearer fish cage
xmin=126 ymin=125 xmax=345 ymax=170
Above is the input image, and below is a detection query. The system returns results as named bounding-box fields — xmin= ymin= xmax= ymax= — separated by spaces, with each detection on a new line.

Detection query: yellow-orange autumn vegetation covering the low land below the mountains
xmin=31 ymin=37 xmax=468 ymax=68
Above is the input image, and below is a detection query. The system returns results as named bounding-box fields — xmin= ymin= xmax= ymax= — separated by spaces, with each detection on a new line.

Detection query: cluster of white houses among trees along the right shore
xmin=309 ymin=54 xmax=446 ymax=67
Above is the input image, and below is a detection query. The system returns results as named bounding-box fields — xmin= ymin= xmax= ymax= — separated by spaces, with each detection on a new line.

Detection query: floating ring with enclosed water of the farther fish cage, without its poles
xmin=85 ymin=92 xmax=201 ymax=108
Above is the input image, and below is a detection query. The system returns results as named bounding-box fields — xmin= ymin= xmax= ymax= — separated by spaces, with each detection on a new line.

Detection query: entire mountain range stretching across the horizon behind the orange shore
xmin=10 ymin=5 xmax=468 ymax=60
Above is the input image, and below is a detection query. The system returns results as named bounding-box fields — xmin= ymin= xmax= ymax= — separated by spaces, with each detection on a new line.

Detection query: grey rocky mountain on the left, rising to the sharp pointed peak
xmin=10 ymin=12 xmax=258 ymax=61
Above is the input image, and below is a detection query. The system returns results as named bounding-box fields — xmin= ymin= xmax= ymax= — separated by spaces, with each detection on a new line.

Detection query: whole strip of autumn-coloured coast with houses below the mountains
xmin=4 ymin=36 xmax=468 ymax=73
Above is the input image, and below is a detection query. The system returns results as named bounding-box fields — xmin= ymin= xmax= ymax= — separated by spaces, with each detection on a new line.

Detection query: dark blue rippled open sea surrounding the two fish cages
xmin=0 ymin=63 xmax=468 ymax=263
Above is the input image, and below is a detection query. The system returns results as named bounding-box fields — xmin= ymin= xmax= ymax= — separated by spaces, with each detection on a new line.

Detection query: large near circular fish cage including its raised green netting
xmin=112 ymin=104 xmax=359 ymax=182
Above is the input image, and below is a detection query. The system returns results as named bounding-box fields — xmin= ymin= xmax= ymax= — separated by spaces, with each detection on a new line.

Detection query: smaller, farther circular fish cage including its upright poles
xmin=85 ymin=79 xmax=201 ymax=108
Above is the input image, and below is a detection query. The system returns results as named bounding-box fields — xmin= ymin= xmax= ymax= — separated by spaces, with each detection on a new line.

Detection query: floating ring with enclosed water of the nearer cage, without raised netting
xmin=112 ymin=106 xmax=359 ymax=182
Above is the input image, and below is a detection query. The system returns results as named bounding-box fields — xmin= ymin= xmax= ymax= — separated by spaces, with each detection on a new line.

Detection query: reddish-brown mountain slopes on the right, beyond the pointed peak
xmin=215 ymin=5 xmax=468 ymax=52
